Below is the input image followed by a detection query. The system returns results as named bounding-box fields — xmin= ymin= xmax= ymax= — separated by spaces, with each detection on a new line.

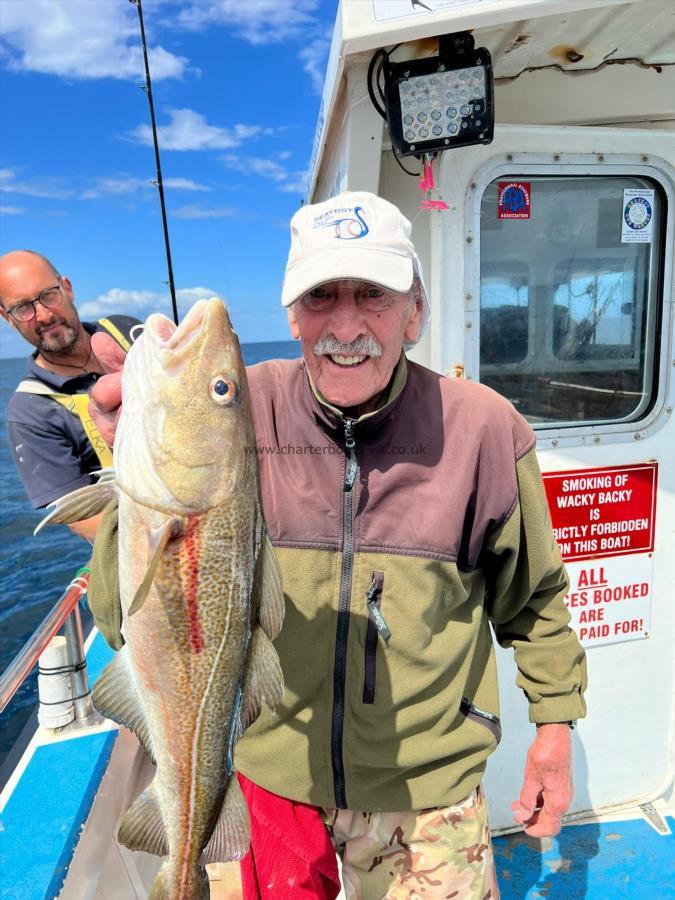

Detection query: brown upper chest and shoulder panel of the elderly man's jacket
xmin=248 ymin=360 xmax=534 ymax=569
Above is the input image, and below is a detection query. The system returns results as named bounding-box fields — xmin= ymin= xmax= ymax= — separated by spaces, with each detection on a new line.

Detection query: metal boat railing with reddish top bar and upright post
xmin=0 ymin=566 xmax=94 ymax=725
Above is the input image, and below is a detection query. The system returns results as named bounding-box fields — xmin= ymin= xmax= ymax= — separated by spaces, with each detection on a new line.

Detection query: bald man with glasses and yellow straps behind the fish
xmin=0 ymin=250 xmax=137 ymax=540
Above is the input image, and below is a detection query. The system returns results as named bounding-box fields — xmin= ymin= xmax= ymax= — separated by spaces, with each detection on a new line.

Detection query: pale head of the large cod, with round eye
xmin=114 ymin=297 xmax=255 ymax=515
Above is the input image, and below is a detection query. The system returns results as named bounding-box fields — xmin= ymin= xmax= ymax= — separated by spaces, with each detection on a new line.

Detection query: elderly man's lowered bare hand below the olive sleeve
xmin=511 ymin=724 xmax=574 ymax=837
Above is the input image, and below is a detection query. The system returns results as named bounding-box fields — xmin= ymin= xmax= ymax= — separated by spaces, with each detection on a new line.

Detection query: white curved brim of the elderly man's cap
xmin=281 ymin=247 xmax=413 ymax=307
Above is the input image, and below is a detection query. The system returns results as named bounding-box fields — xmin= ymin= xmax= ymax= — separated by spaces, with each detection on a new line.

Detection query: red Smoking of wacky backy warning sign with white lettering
xmin=543 ymin=463 xmax=658 ymax=561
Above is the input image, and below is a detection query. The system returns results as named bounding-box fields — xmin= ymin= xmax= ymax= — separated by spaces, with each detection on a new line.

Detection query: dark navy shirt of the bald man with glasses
xmin=7 ymin=316 xmax=138 ymax=509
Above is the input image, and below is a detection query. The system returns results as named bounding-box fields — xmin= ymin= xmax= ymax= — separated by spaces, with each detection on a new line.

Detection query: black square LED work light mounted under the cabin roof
xmin=384 ymin=32 xmax=494 ymax=156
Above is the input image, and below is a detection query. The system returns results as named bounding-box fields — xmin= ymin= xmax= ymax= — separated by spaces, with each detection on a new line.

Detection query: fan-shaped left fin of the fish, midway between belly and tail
xmin=92 ymin=644 xmax=155 ymax=762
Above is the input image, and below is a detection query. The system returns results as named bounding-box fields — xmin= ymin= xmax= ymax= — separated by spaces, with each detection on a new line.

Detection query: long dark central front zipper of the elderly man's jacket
xmin=330 ymin=419 xmax=359 ymax=809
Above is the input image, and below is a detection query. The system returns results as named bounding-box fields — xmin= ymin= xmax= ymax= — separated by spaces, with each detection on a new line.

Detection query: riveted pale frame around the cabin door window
xmin=464 ymin=153 xmax=675 ymax=448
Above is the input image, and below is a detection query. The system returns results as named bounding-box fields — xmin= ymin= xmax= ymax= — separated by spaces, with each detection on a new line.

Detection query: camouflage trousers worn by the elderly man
xmin=324 ymin=787 xmax=499 ymax=900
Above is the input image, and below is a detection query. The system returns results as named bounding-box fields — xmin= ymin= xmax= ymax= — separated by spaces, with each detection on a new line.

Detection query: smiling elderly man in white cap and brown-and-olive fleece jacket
xmin=92 ymin=193 xmax=585 ymax=900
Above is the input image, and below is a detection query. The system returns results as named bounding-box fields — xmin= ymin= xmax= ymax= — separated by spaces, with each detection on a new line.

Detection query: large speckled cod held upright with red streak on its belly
xmin=43 ymin=298 xmax=284 ymax=900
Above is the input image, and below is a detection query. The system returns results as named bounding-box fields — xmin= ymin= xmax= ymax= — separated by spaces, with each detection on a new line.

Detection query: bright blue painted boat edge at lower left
xmin=0 ymin=634 xmax=118 ymax=900
